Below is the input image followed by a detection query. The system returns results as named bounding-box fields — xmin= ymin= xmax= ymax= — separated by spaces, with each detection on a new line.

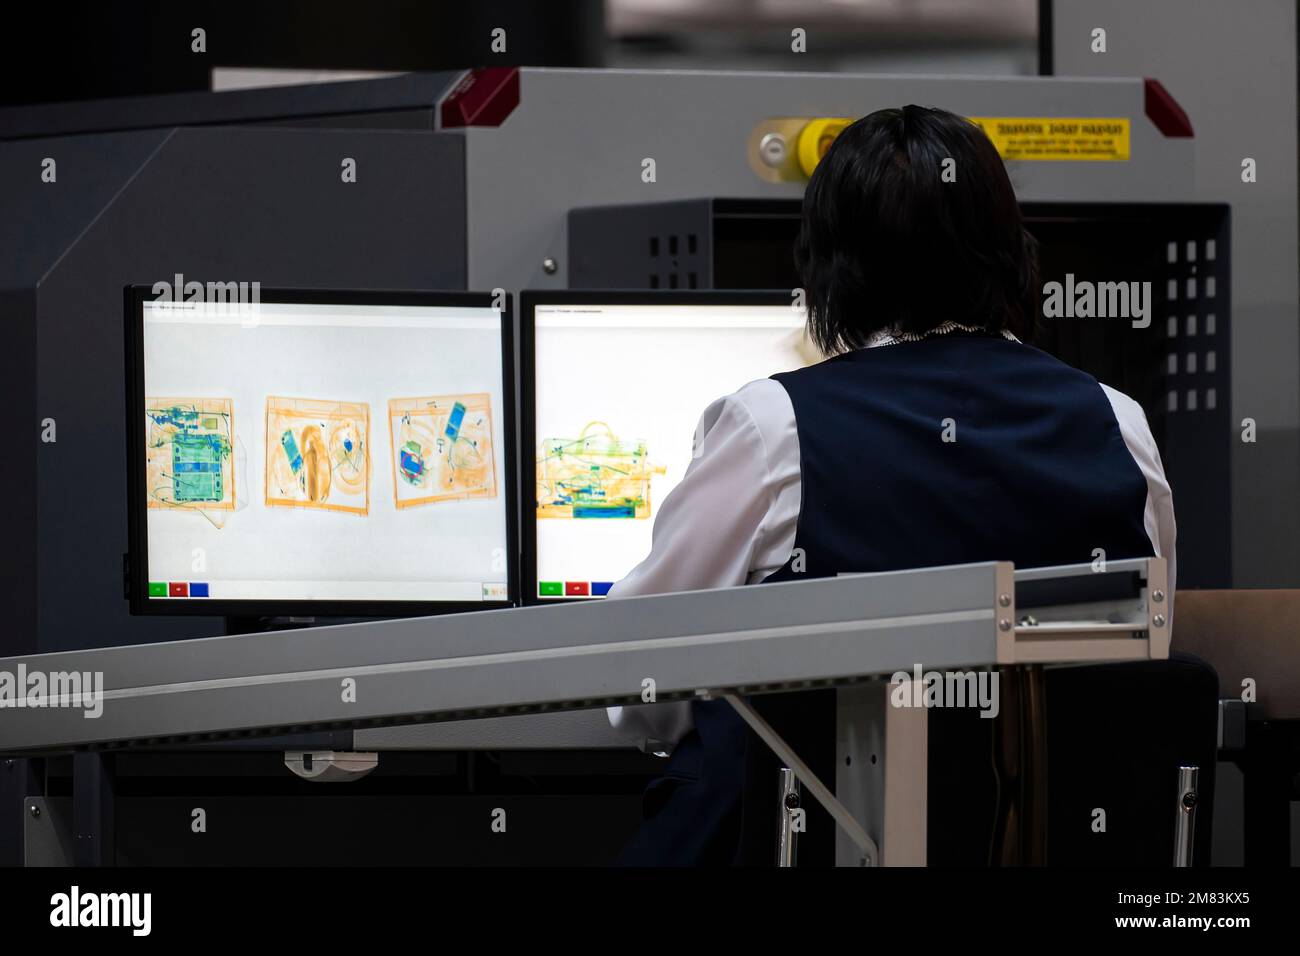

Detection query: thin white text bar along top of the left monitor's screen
xmin=144 ymin=302 xmax=501 ymax=330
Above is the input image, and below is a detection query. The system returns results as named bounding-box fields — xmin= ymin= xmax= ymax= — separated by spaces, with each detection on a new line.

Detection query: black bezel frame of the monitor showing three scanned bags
xmin=125 ymin=285 xmax=520 ymax=618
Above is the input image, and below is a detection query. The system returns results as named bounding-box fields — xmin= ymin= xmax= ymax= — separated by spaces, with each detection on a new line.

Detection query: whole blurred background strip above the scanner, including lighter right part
xmin=0 ymin=0 xmax=1045 ymax=107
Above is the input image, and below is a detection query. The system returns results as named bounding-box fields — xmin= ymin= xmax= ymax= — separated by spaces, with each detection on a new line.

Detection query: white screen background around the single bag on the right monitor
xmin=524 ymin=304 xmax=807 ymax=588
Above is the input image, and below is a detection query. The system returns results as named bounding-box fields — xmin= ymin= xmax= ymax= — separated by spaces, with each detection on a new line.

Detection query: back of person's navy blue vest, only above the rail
xmin=767 ymin=334 xmax=1153 ymax=580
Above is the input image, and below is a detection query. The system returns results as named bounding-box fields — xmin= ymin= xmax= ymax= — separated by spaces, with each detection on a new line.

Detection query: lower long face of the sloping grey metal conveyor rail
xmin=0 ymin=609 xmax=996 ymax=753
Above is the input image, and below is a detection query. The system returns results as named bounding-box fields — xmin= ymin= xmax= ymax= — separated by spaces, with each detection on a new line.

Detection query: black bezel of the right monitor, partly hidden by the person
xmin=519 ymin=289 xmax=793 ymax=606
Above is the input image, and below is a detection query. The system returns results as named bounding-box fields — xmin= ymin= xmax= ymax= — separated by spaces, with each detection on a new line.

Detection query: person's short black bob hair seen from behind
xmin=794 ymin=105 xmax=1039 ymax=355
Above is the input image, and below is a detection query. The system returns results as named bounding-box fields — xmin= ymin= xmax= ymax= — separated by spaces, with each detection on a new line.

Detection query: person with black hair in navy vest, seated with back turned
xmin=610 ymin=105 xmax=1175 ymax=865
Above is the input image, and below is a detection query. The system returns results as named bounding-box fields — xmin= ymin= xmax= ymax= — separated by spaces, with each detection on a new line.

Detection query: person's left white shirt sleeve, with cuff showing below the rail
xmin=608 ymin=378 xmax=800 ymax=744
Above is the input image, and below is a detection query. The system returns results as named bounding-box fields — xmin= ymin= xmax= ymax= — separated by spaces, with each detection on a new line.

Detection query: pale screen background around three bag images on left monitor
xmin=135 ymin=303 xmax=512 ymax=600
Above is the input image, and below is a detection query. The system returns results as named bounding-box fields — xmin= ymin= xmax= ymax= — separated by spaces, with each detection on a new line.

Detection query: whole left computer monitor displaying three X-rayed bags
xmin=126 ymin=280 xmax=517 ymax=617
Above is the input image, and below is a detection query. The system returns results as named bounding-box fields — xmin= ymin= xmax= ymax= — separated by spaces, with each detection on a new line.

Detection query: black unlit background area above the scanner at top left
xmin=0 ymin=0 xmax=605 ymax=105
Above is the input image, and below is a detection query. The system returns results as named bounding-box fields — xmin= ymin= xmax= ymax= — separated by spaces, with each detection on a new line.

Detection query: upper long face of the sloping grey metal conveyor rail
xmin=10 ymin=562 xmax=996 ymax=693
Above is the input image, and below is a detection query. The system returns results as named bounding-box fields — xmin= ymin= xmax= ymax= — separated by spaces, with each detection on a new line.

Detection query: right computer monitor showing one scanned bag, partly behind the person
xmin=520 ymin=291 xmax=820 ymax=602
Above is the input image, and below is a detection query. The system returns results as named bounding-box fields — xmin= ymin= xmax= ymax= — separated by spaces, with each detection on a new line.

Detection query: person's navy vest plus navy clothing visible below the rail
xmin=623 ymin=333 xmax=1153 ymax=865
